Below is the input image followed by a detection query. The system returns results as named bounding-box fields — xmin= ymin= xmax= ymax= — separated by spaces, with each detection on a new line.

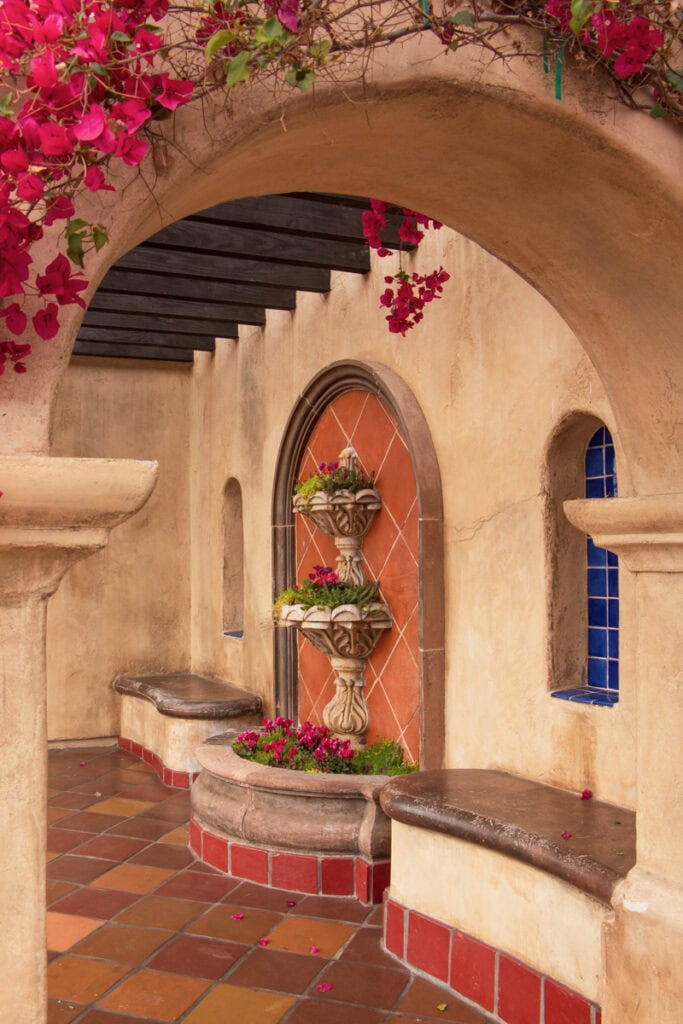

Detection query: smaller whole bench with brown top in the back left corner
xmin=113 ymin=672 xmax=262 ymax=787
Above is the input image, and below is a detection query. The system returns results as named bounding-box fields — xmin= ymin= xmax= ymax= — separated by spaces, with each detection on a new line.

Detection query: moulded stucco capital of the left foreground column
xmin=0 ymin=456 xmax=158 ymax=604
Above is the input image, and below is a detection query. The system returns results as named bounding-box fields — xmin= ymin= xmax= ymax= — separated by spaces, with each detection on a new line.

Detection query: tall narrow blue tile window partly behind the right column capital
xmin=586 ymin=427 xmax=618 ymax=694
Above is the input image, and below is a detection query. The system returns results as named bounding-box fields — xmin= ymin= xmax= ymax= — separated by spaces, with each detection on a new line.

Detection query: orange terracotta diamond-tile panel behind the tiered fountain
xmin=296 ymin=391 xmax=420 ymax=761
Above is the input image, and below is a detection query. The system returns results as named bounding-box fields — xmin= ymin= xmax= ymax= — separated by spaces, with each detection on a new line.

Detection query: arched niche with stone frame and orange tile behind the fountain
xmin=273 ymin=362 xmax=443 ymax=767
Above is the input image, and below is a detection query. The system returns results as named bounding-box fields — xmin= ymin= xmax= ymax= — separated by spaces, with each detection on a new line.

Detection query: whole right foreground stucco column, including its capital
xmin=564 ymin=494 xmax=683 ymax=1024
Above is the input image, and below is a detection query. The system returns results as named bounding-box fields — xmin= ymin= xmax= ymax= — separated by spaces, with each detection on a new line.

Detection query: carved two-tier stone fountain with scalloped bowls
xmin=280 ymin=447 xmax=391 ymax=748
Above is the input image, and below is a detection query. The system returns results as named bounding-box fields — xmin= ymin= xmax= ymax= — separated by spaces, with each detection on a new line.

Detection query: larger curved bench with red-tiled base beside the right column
xmin=381 ymin=769 xmax=636 ymax=1024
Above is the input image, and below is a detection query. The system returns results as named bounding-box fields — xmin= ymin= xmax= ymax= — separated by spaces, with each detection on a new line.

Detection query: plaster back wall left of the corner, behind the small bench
xmin=47 ymin=358 xmax=190 ymax=739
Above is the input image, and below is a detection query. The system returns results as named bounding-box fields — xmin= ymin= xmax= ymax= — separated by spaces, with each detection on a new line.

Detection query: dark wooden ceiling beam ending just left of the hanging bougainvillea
xmin=150 ymin=217 xmax=370 ymax=273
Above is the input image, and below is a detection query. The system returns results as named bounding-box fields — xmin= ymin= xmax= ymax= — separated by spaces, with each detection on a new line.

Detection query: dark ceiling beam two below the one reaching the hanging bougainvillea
xmin=99 ymin=265 xmax=296 ymax=309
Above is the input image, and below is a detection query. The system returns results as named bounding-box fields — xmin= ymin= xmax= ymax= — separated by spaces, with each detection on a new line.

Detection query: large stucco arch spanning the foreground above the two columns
xmin=3 ymin=40 xmax=683 ymax=503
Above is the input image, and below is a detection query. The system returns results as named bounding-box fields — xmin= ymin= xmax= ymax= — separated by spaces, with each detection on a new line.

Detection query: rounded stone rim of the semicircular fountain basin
xmin=197 ymin=743 xmax=395 ymax=803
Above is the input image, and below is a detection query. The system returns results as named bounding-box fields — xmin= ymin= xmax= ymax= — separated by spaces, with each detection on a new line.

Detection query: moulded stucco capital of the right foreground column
xmin=564 ymin=493 xmax=683 ymax=572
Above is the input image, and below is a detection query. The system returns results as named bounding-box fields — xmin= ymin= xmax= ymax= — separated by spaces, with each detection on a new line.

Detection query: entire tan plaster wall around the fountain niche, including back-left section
xmin=49 ymin=229 xmax=635 ymax=806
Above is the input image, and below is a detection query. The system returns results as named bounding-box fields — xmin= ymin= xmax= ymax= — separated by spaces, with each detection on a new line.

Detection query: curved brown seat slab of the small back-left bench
xmin=113 ymin=672 xmax=262 ymax=719
